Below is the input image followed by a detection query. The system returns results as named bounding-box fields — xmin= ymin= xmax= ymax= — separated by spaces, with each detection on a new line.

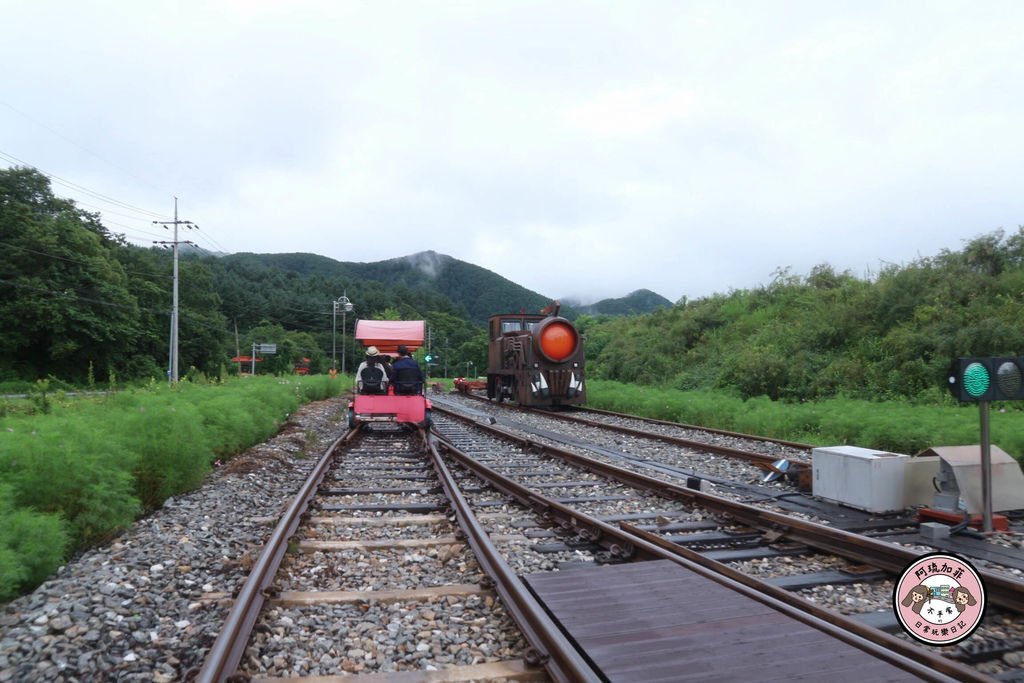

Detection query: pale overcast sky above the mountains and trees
xmin=0 ymin=0 xmax=1024 ymax=301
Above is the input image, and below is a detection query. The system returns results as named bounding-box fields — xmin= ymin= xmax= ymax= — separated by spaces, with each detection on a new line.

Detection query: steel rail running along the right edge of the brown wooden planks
xmin=430 ymin=424 xmax=992 ymax=682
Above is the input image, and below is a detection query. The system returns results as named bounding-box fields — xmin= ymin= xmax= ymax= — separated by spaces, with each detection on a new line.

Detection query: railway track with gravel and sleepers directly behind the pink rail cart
xmin=195 ymin=423 xmax=596 ymax=681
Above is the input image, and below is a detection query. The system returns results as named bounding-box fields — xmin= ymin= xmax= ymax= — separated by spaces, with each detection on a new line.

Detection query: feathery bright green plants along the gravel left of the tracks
xmin=0 ymin=376 xmax=348 ymax=601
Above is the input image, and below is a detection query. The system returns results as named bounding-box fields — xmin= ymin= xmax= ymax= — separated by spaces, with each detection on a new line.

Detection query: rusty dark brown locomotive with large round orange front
xmin=487 ymin=301 xmax=587 ymax=407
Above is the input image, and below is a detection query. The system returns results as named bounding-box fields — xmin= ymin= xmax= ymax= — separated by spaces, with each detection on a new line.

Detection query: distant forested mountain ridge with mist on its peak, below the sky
xmin=223 ymin=251 xmax=672 ymax=323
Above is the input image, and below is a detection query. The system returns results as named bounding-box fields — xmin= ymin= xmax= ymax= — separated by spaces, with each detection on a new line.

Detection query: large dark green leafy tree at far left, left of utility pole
xmin=0 ymin=168 xmax=139 ymax=382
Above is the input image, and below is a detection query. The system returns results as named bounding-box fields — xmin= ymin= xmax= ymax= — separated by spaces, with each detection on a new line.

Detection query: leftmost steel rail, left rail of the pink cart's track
xmin=195 ymin=430 xmax=358 ymax=683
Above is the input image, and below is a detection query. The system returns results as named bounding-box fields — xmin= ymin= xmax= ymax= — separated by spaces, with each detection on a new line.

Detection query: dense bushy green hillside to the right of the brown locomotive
xmin=580 ymin=229 xmax=1024 ymax=410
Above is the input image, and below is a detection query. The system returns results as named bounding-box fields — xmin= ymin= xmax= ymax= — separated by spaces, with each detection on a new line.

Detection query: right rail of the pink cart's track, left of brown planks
xmin=429 ymin=440 xmax=602 ymax=683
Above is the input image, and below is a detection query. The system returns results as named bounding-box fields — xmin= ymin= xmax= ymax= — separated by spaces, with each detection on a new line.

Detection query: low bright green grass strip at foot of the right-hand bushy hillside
xmin=587 ymin=380 xmax=1024 ymax=461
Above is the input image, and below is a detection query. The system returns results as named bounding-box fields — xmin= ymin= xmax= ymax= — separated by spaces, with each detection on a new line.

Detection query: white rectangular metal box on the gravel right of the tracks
xmin=811 ymin=445 xmax=909 ymax=512
